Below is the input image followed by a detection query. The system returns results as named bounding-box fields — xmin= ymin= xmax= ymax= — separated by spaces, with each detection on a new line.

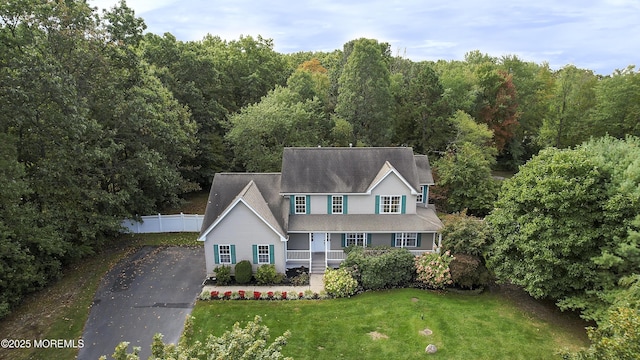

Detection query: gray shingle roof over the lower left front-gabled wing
xmin=200 ymin=173 xmax=288 ymax=236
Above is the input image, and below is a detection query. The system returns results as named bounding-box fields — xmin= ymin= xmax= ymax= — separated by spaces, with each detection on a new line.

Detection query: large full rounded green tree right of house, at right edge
xmin=487 ymin=137 xmax=640 ymax=320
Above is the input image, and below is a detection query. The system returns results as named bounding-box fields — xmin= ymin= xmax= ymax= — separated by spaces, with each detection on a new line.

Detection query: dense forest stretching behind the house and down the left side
xmin=0 ymin=0 xmax=640 ymax=324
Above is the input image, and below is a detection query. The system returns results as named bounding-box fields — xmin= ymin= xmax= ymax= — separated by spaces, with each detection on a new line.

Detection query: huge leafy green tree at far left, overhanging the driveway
xmin=0 ymin=1 xmax=195 ymax=316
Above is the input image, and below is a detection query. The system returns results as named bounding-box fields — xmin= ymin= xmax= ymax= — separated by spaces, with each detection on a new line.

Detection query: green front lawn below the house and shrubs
xmin=190 ymin=289 xmax=588 ymax=360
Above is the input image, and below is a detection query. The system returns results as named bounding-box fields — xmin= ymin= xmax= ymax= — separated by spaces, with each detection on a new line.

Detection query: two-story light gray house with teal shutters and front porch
xmin=199 ymin=147 xmax=442 ymax=274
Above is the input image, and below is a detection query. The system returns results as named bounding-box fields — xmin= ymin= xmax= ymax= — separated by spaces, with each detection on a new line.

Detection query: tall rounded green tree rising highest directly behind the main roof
xmin=336 ymin=38 xmax=393 ymax=146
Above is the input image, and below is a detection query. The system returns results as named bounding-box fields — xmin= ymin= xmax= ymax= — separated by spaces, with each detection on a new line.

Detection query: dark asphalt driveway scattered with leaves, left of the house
xmin=78 ymin=247 xmax=206 ymax=360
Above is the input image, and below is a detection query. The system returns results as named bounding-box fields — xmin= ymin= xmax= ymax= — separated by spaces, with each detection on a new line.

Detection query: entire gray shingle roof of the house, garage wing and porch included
xmin=200 ymin=148 xmax=442 ymax=236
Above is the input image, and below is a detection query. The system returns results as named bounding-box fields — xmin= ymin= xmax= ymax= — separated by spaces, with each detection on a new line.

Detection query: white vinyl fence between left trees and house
xmin=122 ymin=213 xmax=204 ymax=234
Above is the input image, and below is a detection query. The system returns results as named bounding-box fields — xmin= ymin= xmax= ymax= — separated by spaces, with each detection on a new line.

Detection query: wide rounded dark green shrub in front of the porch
xmin=341 ymin=247 xmax=415 ymax=290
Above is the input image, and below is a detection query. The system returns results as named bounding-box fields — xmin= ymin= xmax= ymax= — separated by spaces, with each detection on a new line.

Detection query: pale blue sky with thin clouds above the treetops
xmin=89 ymin=0 xmax=640 ymax=75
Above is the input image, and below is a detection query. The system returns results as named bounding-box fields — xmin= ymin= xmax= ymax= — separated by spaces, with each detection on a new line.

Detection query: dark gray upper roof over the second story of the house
xmin=280 ymin=147 xmax=428 ymax=194
